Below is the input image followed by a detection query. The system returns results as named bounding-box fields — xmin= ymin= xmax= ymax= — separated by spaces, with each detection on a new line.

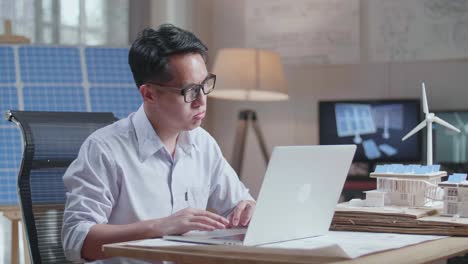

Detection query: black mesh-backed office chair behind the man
xmin=6 ymin=111 xmax=117 ymax=263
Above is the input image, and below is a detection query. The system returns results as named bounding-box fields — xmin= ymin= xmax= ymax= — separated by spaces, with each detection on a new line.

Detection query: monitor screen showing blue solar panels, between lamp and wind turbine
xmin=319 ymin=100 xmax=421 ymax=162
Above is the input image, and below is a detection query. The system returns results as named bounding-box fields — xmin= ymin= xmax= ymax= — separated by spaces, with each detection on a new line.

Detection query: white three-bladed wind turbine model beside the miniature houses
xmin=401 ymin=82 xmax=460 ymax=165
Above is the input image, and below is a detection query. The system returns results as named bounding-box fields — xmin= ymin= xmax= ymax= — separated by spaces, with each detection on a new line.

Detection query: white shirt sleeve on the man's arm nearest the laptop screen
xmin=208 ymin=143 xmax=254 ymax=216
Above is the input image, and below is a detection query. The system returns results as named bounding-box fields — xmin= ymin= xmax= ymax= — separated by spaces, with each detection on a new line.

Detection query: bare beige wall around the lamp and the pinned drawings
xmin=148 ymin=0 xmax=468 ymax=196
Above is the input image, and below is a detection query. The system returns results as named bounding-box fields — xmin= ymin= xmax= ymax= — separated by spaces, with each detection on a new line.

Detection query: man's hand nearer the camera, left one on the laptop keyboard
xmin=158 ymin=208 xmax=229 ymax=236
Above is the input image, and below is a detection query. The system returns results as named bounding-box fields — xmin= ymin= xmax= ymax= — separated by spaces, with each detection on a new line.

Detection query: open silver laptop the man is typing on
xmin=163 ymin=145 xmax=356 ymax=246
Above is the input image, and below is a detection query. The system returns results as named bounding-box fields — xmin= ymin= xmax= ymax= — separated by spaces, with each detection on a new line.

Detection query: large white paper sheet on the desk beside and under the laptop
xmin=262 ymin=231 xmax=446 ymax=258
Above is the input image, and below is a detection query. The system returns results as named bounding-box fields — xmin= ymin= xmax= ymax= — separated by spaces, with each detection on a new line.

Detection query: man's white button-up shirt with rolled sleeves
xmin=62 ymin=106 xmax=253 ymax=263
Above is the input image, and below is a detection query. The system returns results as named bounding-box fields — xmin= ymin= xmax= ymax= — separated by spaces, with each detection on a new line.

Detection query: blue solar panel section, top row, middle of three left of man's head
xmin=19 ymin=46 xmax=83 ymax=84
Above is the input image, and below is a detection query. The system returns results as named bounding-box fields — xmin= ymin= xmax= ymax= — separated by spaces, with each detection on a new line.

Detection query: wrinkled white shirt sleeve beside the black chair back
xmin=62 ymin=138 xmax=118 ymax=262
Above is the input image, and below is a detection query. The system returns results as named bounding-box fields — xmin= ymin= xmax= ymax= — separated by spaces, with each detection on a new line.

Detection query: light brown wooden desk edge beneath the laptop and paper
xmin=103 ymin=237 xmax=468 ymax=264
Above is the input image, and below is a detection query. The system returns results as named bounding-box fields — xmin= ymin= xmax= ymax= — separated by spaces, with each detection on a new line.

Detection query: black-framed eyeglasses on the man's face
xmin=147 ymin=73 xmax=216 ymax=103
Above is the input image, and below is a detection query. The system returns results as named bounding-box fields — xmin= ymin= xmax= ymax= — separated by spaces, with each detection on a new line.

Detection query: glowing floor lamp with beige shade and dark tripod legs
xmin=210 ymin=48 xmax=288 ymax=177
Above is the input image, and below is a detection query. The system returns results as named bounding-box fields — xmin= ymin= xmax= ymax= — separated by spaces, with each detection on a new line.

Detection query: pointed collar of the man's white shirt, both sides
xmin=133 ymin=105 xmax=197 ymax=161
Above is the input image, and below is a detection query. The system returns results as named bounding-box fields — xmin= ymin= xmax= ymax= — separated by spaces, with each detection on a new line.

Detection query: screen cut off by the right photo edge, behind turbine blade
xmin=434 ymin=110 xmax=468 ymax=164
